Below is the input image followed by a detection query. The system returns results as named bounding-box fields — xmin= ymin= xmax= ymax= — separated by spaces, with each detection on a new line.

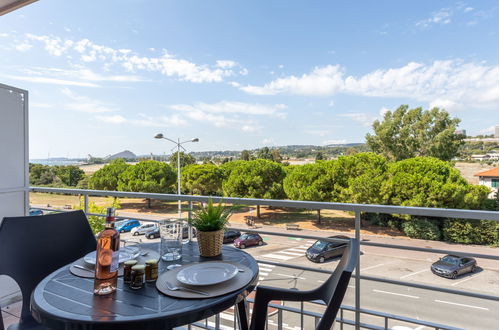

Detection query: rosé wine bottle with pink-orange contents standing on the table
xmin=94 ymin=207 xmax=120 ymax=295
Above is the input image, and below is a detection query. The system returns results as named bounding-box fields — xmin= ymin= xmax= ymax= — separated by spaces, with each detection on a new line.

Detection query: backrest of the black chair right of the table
xmin=316 ymin=239 xmax=359 ymax=330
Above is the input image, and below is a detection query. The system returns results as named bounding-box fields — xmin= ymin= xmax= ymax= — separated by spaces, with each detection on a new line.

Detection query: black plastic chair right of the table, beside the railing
xmin=250 ymin=239 xmax=359 ymax=330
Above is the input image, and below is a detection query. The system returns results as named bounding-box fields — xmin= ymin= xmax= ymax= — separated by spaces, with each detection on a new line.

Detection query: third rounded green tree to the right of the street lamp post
xmin=283 ymin=162 xmax=333 ymax=223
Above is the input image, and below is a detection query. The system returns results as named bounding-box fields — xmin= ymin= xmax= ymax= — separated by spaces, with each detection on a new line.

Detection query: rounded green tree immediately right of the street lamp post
xmin=182 ymin=164 xmax=224 ymax=196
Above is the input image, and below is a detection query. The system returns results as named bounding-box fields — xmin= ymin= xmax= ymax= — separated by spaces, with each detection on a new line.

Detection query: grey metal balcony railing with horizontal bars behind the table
xmin=30 ymin=187 xmax=499 ymax=329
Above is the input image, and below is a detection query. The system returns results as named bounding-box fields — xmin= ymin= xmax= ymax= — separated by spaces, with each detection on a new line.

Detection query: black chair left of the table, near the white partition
xmin=0 ymin=211 xmax=97 ymax=330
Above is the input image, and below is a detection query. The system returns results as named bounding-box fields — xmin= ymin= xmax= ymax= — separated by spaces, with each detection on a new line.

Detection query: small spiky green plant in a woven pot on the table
xmin=189 ymin=198 xmax=232 ymax=257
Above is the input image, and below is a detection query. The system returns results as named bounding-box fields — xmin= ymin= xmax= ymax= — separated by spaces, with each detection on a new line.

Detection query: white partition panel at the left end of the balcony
xmin=0 ymin=84 xmax=29 ymax=219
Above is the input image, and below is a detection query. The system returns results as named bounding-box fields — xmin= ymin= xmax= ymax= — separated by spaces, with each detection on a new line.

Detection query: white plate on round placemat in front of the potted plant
xmin=177 ymin=261 xmax=239 ymax=285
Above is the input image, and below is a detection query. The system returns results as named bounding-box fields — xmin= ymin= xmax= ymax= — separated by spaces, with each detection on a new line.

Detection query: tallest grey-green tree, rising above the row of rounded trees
xmin=366 ymin=105 xmax=464 ymax=160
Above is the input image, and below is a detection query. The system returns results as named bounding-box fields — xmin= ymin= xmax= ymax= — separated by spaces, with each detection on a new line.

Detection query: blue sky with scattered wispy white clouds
xmin=0 ymin=0 xmax=499 ymax=158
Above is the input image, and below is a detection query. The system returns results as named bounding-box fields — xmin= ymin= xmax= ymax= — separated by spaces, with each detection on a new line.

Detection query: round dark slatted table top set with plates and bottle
xmin=31 ymin=243 xmax=258 ymax=330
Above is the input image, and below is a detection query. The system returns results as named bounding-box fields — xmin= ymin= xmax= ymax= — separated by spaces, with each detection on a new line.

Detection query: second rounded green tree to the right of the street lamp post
xmin=222 ymin=159 xmax=286 ymax=218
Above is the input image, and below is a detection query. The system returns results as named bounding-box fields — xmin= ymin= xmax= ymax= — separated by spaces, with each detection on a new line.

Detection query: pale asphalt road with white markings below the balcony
xmin=122 ymin=222 xmax=499 ymax=329
